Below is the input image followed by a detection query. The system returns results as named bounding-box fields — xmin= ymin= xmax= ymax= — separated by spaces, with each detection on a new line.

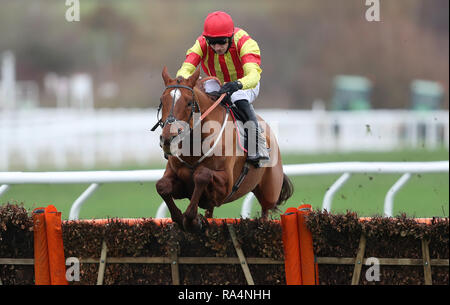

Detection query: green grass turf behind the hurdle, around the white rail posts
xmin=0 ymin=150 xmax=449 ymax=219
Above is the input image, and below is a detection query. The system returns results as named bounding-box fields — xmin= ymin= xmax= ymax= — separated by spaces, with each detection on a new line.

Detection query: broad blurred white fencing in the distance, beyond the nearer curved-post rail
xmin=0 ymin=108 xmax=449 ymax=171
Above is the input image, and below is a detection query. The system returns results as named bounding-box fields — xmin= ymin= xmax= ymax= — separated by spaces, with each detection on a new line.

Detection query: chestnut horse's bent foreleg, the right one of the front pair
xmin=183 ymin=167 xmax=213 ymax=223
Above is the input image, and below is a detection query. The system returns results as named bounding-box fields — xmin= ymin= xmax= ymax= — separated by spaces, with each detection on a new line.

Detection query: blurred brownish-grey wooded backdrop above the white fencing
xmin=0 ymin=0 xmax=449 ymax=109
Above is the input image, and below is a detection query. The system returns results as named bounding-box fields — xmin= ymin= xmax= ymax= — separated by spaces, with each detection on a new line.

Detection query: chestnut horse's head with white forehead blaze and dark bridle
xmin=160 ymin=67 xmax=200 ymax=155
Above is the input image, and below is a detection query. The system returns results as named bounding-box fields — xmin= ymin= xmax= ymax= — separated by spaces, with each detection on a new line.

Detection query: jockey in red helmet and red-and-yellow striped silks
xmin=176 ymin=11 xmax=269 ymax=162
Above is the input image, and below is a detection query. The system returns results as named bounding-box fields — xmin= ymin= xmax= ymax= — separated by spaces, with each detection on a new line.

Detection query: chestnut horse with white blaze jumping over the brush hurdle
xmin=156 ymin=67 xmax=293 ymax=231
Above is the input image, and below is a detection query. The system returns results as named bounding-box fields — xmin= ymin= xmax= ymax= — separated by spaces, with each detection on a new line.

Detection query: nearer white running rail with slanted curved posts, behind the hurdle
xmin=0 ymin=161 xmax=449 ymax=220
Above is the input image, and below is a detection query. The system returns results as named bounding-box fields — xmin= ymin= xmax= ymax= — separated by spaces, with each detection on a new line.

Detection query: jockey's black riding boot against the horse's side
xmin=234 ymin=100 xmax=270 ymax=163
